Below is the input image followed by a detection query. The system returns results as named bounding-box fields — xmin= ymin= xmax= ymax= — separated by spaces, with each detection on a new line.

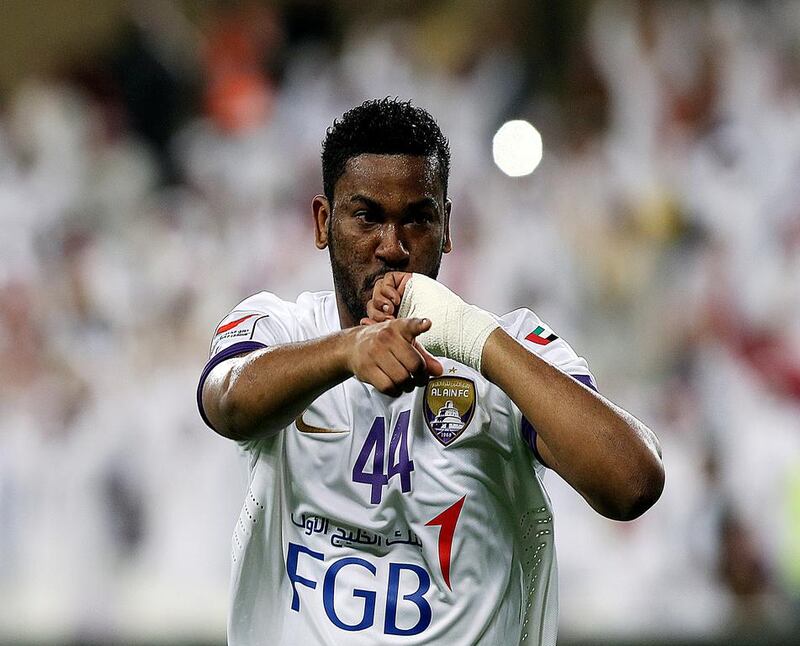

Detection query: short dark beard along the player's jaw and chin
xmin=328 ymin=227 xmax=442 ymax=325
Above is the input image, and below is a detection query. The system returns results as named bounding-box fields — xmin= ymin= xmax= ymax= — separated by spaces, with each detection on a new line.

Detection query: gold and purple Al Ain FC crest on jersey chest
xmin=422 ymin=377 xmax=476 ymax=446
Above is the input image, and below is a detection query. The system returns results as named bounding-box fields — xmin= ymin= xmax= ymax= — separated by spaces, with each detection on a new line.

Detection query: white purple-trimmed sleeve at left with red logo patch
xmin=197 ymin=292 xmax=296 ymax=427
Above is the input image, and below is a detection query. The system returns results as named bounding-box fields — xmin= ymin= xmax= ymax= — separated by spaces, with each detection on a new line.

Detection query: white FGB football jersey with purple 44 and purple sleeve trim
xmin=198 ymin=292 xmax=594 ymax=646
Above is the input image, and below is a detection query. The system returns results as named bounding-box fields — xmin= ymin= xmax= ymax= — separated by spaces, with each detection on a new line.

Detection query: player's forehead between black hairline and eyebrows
xmin=335 ymin=153 xmax=444 ymax=203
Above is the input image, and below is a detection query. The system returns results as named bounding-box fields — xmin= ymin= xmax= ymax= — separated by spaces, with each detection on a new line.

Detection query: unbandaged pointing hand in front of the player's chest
xmin=348 ymin=318 xmax=443 ymax=397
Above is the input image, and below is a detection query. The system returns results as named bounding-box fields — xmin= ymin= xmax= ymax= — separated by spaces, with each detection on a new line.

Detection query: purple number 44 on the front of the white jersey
xmin=353 ymin=410 xmax=414 ymax=505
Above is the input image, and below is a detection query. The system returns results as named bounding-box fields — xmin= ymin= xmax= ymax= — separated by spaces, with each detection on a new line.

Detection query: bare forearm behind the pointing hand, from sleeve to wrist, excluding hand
xmin=203 ymin=330 xmax=352 ymax=441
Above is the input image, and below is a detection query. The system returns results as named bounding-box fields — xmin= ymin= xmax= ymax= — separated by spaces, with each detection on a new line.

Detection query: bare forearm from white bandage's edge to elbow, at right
xmin=482 ymin=329 xmax=664 ymax=520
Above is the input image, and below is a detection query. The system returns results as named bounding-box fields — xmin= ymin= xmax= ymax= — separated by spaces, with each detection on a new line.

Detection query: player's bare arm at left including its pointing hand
xmin=202 ymin=306 xmax=443 ymax=441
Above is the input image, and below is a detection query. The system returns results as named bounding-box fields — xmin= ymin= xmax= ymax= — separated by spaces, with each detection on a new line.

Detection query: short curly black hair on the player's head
xmin=322 ymin=97 xmax=450 ymax=204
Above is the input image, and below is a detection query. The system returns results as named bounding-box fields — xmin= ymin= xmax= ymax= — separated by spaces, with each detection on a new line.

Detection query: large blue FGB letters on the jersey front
xmin=286 ymin=542 xmax=432 ymax=636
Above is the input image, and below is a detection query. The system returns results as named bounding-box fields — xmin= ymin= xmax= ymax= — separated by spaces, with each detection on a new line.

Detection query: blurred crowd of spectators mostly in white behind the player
xmin=0 ymin=0 xmax=800 ymax=639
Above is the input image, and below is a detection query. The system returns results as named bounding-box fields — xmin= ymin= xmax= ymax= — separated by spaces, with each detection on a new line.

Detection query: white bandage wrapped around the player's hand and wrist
xmin=397 ymin=274 xmax=500 ymax=372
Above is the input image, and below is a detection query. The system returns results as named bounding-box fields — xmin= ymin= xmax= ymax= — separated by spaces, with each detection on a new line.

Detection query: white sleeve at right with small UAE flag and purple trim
xmin=499 ymin=309 xmax=597 ymax=466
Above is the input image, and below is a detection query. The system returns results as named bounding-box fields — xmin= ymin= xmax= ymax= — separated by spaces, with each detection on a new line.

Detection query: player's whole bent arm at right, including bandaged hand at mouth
xmin=378 ymin=274 xmax=664 ymax=520
